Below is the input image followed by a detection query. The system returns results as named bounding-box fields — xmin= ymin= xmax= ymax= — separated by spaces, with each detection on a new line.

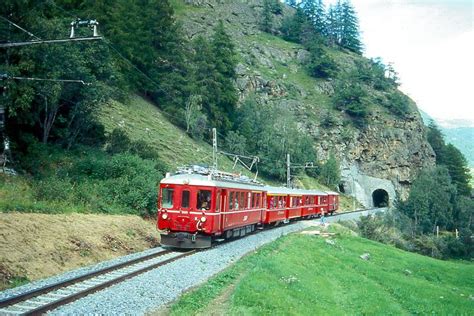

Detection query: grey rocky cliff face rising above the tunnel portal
xmin=180 ymin=0 xmax=435 ymax=207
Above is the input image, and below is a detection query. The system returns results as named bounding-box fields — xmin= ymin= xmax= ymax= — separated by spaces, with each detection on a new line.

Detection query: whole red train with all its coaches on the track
xmin=158 ymin=167 xmax=339 ymax=248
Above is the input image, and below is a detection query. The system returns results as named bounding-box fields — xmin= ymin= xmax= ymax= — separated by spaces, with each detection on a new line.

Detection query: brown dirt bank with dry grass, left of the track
xmin=0 ymin=213 xmax=159 ymax=290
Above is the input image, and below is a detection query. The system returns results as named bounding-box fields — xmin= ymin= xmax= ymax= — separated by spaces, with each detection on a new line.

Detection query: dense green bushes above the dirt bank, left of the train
xmin=14 ymin=143 xmax=169 ymax=216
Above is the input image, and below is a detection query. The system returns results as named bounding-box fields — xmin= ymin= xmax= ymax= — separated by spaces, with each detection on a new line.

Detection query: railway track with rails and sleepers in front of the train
xmin=0 ymin=250 xmax=196 ymax=315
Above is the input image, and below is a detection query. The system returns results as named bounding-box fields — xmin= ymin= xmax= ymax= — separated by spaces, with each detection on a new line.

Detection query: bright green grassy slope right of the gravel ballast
xmin=170 ymin=226 xmax=474 ymax=315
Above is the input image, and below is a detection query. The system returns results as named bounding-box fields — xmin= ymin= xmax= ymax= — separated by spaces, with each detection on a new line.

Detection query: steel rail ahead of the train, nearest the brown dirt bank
xmin=0 ymin=250 xmax=172 ymax=308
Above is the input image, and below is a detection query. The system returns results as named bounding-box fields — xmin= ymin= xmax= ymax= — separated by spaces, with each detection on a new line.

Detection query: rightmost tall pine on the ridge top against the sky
xmin=338 ymin=0 xmax=362 ymax=54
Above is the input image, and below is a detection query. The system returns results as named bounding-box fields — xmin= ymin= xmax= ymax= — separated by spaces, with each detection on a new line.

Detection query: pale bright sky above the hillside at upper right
xmin=324 ymin=0 xmax=474 ymax=127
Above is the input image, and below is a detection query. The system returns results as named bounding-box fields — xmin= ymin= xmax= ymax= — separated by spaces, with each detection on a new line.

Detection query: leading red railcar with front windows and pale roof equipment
xmin=158 ymin=169 xmax=266 ymax=248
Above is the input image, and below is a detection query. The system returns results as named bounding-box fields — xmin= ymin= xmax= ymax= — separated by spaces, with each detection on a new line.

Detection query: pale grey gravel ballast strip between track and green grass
xmin=51 ymin=222 xmax=309 ymax=315
